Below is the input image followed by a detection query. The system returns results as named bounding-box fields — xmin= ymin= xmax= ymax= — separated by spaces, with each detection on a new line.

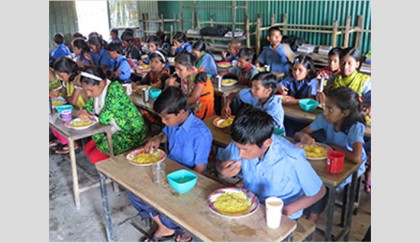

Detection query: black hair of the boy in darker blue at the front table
xmin=153 ymin=86 xmax=188 ymax=115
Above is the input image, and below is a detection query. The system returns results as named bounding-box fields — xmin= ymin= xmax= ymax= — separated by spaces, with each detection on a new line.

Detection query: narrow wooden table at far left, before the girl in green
xmin=49 ymin=109 xmax=114 ymax=210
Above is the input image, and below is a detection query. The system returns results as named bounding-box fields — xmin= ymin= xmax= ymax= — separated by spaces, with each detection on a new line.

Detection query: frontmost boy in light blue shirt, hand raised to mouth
xmin=216 ymin=107 xmax=326 ymax=220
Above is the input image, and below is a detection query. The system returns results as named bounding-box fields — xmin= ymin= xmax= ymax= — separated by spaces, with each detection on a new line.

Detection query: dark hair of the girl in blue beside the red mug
xmin=327 ymin=87 xmax=365 ymax=133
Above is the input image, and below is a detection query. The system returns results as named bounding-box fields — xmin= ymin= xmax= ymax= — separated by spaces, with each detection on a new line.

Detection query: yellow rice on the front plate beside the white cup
xmin=214 ymin=192 xmax=251 ymax=215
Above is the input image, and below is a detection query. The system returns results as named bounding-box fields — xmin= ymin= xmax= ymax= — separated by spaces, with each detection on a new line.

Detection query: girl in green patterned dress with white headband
xmin=78 ymin=66 xmax=146 ymax=164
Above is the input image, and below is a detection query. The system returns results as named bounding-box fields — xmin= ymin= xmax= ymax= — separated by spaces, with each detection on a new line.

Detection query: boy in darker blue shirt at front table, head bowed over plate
xmin=128 ymin=87 xmax=213 ymax=241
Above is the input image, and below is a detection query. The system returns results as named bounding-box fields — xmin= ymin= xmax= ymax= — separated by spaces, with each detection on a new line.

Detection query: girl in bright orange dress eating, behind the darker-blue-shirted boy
xmin=166 ymin=51 xmax=214 ymax=120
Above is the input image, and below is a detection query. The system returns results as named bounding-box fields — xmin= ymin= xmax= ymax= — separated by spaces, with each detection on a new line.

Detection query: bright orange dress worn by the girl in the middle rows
xmin=181 ymin=68 xmax=214 ymax=120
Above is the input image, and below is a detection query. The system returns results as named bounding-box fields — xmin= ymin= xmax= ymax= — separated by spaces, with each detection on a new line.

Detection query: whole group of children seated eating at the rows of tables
xmin=50 ymin=27 xmax=371 ymax=241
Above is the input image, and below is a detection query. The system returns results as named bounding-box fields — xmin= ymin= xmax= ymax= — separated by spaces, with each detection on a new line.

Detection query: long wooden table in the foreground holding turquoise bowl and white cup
xmin=95 ymin=153 xmax=296 ymax=241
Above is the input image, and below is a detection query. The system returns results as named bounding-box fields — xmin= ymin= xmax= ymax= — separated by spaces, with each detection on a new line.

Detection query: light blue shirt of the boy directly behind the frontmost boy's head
xmin=239 ymin=88 xmax=284 ymax=129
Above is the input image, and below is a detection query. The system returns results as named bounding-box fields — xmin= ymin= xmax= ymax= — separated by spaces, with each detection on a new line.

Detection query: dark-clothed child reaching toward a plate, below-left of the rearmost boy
xmin=220 ymin=47 xmax=258 ymax=87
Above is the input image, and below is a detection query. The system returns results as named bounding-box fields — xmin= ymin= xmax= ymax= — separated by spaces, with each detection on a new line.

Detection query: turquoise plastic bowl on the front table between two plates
xmin=166 ymin=169 xmax=198 ymax=194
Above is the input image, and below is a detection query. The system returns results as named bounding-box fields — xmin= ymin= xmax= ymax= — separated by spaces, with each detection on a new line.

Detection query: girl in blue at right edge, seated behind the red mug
xmin=295 ymin=87 xmax=367 ymax=189
